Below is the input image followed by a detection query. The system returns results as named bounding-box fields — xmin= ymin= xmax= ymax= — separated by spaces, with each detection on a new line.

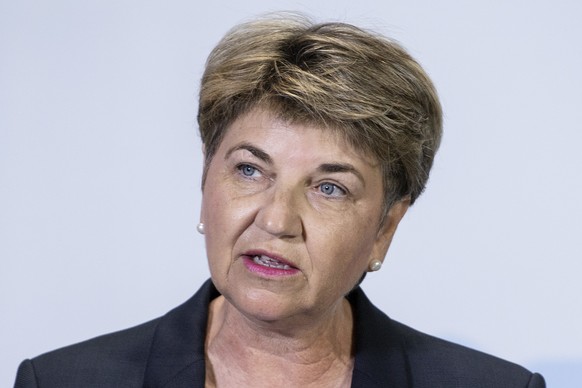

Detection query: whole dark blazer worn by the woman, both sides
xmin=15 ymin=280 xmax=545 ymax=388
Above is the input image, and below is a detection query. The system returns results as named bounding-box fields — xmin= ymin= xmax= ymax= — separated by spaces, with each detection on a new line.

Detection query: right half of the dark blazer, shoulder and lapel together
xmin=348 ymin=288 xmax=545 ymax=388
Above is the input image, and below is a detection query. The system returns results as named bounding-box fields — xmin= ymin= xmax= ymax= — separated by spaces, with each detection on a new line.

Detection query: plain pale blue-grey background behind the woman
xmin=0 ymin=0 xmax=582 ymax=387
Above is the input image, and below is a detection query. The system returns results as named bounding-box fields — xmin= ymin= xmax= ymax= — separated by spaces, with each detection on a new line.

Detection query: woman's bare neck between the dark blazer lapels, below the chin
xmin=206 ymin=296 xmax=353 ymax=387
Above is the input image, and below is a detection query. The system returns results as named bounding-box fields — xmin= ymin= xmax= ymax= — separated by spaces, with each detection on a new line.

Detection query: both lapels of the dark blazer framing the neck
xmin=144 ymin=280 xmax=412 ymax=388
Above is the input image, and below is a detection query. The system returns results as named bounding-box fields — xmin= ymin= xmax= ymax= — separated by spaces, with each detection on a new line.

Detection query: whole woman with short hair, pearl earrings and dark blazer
xmin=16 ymin=13 xmax=544 ymax=387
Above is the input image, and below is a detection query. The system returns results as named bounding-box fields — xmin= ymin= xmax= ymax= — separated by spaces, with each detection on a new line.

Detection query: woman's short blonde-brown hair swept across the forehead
xmin=198 ymin=14 xmax=442 ymax=220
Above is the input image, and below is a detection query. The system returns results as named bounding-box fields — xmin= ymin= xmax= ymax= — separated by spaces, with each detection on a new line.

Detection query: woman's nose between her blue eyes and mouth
xmin=255 ymin=187 xmax=303 ymax=238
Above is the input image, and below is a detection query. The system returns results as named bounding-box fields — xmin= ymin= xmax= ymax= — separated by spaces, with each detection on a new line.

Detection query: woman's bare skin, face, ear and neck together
xmin=201 ymin=109 xmax=409 ymax=387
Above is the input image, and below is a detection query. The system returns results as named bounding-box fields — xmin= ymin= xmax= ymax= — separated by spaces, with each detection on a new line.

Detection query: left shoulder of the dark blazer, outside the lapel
xmin=15 ymin=319 xmax=159 ymax=388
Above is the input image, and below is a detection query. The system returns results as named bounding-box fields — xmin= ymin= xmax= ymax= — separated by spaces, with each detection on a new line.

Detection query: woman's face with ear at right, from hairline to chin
xmin=202 ymin=110 xmax=407 ymax=321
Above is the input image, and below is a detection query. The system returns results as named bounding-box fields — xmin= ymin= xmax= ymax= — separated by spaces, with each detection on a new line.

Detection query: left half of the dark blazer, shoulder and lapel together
xmin=15 ymin=280 xmax=218 ymax=388
